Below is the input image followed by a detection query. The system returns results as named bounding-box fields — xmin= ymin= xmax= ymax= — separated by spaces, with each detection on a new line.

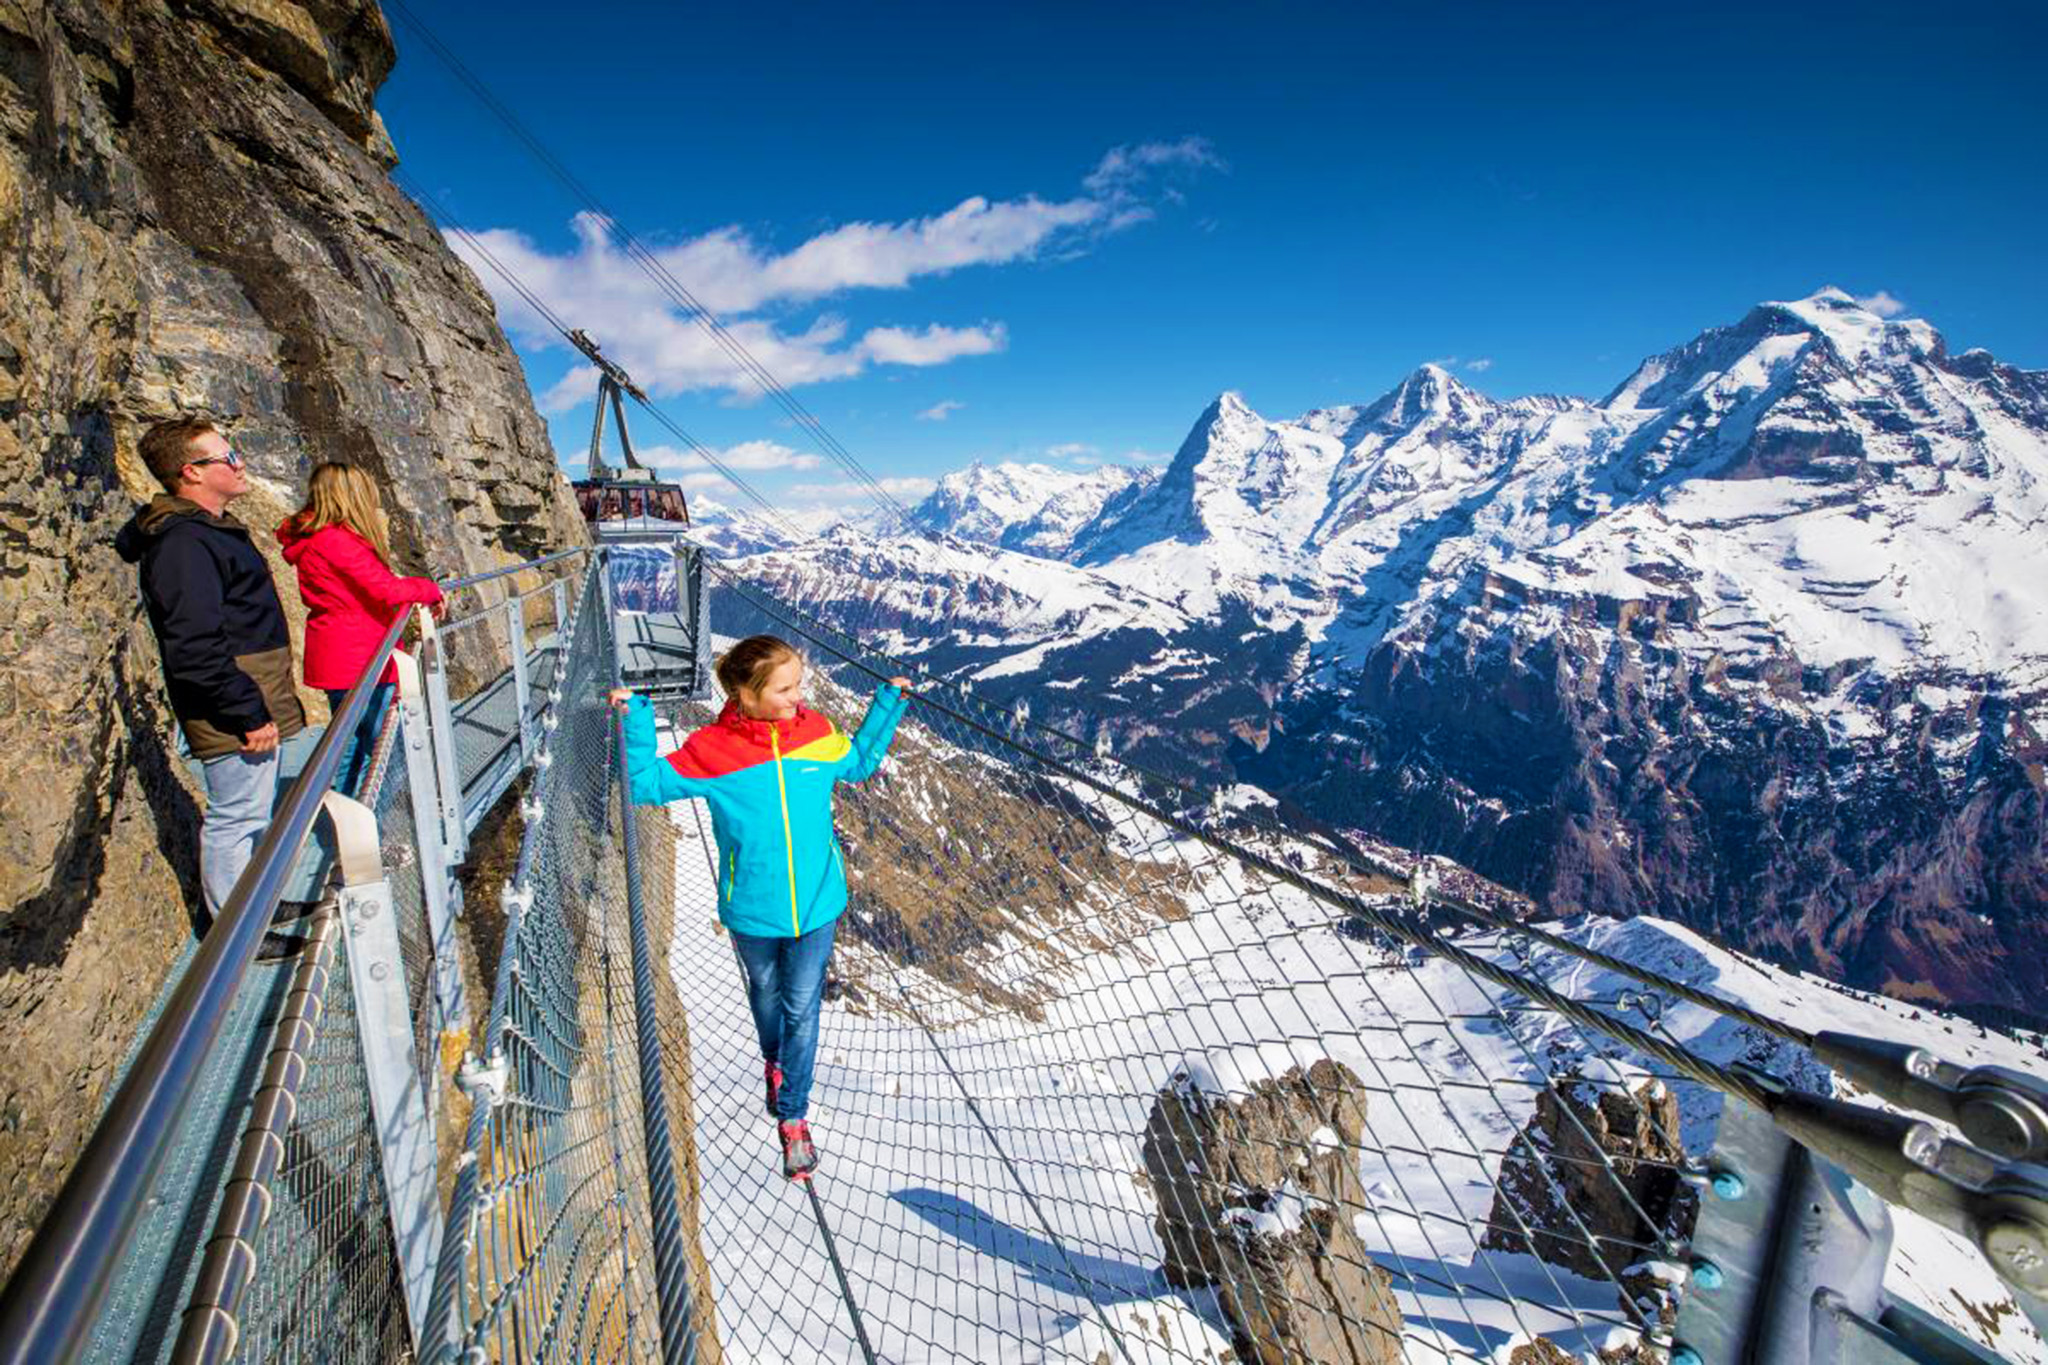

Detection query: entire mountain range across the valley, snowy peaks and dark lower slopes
xmin=737 ymin=289 xmax=2048 ymax=1007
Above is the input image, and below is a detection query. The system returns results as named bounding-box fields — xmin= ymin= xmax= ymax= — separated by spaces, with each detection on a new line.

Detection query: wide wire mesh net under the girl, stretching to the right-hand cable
xmin=622 ymin=583 xmax=1712 ymax=1361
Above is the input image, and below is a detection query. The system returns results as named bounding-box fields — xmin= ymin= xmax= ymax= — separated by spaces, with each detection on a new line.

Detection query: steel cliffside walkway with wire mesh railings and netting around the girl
xmin=0 ymin=544 xmax=2048 ymax=1365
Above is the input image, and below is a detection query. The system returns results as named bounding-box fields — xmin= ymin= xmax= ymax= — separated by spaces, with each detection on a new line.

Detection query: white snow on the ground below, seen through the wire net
xmin=670 ymin=716 xmax=2048 ymax=1365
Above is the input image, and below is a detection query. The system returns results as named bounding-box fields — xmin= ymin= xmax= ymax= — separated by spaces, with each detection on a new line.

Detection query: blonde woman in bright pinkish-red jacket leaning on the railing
xmin=276 ymin=463 xmax=440 ymax=796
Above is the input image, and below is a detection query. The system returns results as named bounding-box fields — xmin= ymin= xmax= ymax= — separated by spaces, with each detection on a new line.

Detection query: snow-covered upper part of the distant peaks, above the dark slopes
xmin=770 ymin=289 xmax=2048 ymax=690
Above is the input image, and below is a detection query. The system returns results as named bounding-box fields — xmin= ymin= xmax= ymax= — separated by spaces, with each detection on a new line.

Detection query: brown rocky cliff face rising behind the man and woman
xmin=0 ymin=0 xmax=582 ymax=1271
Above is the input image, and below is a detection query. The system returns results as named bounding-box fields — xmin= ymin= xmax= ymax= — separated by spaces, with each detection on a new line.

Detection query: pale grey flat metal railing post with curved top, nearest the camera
xmin=328 ymin=796 xmax=442 ymax=1349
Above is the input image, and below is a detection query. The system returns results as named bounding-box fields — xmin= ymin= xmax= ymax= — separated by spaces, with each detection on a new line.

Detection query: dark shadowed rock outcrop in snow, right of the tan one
xmin=1481 ymin=1078 xmax=1698 ymax=1293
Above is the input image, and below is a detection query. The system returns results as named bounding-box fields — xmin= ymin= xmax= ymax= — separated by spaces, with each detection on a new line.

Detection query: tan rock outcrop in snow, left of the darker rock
xmin=1143 ymin=1058 xmax=1403 ymax=1365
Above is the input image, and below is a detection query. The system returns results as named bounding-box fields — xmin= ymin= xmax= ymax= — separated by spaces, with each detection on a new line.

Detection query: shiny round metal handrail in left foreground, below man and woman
xmin=0 ymin=616 xmax=408 ymax=1365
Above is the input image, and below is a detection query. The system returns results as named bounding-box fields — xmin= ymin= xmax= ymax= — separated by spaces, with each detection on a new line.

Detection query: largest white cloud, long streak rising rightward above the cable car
xmin=449 ymin=137 xmax=1223 ymax=403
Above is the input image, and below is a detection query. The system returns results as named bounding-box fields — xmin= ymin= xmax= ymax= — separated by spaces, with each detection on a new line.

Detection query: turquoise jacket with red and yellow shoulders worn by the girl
xmin=627 ymin=684 xmax=909 ymax=939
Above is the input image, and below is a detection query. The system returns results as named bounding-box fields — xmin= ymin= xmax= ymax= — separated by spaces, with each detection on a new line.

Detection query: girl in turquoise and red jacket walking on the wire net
xmin=610 ymin=634 xmax=909 ymax=1181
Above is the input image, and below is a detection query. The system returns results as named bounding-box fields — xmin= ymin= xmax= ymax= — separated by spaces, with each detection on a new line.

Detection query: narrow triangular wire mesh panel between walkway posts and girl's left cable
xmin=428 ymin=560 xmax=688 ymax=1361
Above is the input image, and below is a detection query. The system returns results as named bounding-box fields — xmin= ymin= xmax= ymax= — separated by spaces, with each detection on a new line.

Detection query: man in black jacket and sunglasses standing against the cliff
xmin=115 ymin=417 xmax=305 ymax=956
